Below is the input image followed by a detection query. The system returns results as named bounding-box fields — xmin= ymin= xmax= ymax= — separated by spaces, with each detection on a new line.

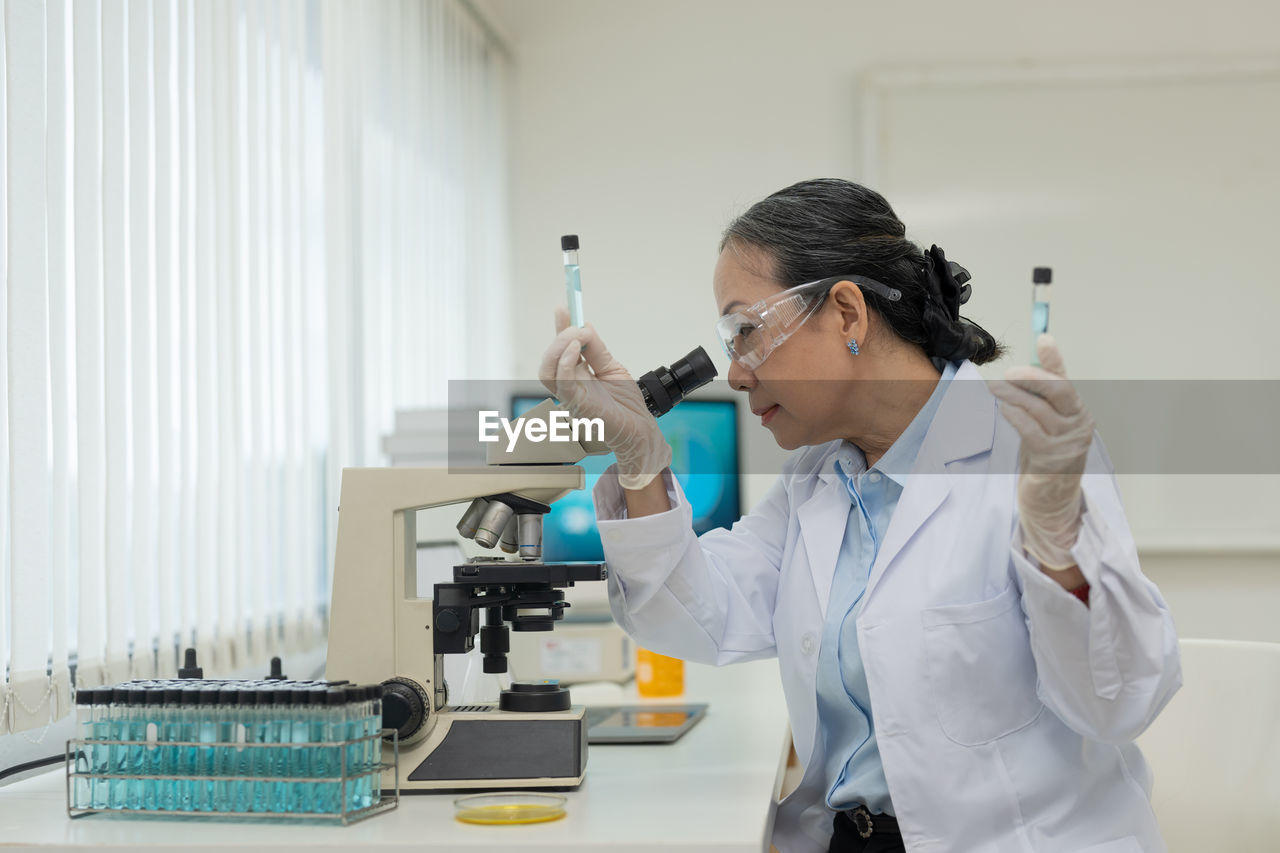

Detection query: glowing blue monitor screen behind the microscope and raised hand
xmin=511 ymin=397 xmax=741 ymax=562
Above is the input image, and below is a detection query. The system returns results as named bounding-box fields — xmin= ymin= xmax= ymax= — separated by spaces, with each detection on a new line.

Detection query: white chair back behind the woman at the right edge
xmin=1138 ymin=639 xmax=1280 ymax=853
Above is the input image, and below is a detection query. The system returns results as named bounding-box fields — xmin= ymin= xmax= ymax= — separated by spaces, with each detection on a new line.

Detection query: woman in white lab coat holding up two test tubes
xmin=540 ymin=179 xmax=1181 ymax=853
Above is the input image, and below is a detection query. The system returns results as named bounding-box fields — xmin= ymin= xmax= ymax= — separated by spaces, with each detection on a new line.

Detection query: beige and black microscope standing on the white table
xmin=325 ymin=347 xmax=716 ymax=793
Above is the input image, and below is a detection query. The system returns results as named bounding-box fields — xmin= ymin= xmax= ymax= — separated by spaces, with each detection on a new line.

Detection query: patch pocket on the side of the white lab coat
xmin=920 ymin=581 xmax=1043 ymax=747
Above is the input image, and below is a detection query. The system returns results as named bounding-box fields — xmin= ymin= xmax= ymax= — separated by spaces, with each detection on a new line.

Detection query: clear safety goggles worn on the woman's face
xmin=716 ymin=275 xmax=902 ymax=370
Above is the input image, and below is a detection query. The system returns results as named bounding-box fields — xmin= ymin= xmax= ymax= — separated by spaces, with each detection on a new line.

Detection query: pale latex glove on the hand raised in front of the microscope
xmin=538 ymin=309 xmax=671 ymax=489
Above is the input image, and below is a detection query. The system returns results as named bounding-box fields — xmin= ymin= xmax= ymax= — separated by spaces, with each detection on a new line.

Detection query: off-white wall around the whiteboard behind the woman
xmin=484 ymin=0 xmax=1280 ymax=640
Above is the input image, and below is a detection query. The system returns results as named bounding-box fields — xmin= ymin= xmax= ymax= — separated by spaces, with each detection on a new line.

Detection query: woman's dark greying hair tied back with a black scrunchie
xmin=721 ymin=178 xmax=1005 ymax=364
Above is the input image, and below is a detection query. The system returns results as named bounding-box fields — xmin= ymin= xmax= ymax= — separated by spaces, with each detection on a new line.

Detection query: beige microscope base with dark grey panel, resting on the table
xmin=384 ymin=704 xmax=586 ymax=793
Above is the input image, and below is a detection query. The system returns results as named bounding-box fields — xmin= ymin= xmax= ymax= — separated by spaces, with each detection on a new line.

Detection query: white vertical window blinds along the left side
xmin=0 ymin=0 xmax=509 ymax=740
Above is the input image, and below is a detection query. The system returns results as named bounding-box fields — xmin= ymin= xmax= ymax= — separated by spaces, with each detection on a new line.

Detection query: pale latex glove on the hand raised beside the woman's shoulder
xmin=992 ymin=334 xmax=1093 ymax=570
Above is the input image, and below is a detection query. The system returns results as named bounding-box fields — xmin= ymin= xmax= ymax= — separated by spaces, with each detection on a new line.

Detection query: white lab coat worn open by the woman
xmin=595 ymin=361 xmax=1181 ymax=853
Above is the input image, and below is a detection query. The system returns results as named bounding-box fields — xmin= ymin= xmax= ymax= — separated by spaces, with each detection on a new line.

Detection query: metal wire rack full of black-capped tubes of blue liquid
xmin=65 ymin=681 xmax=399 ymax=825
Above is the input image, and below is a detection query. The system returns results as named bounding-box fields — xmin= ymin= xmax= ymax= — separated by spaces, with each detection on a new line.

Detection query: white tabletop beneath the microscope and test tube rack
xmin=0 ymin=661 xmax=790 ymax=853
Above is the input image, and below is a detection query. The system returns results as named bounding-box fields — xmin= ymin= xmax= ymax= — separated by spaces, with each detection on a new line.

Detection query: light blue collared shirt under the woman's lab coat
xmin=818 ymin=362 xmax=956 ymax=815
